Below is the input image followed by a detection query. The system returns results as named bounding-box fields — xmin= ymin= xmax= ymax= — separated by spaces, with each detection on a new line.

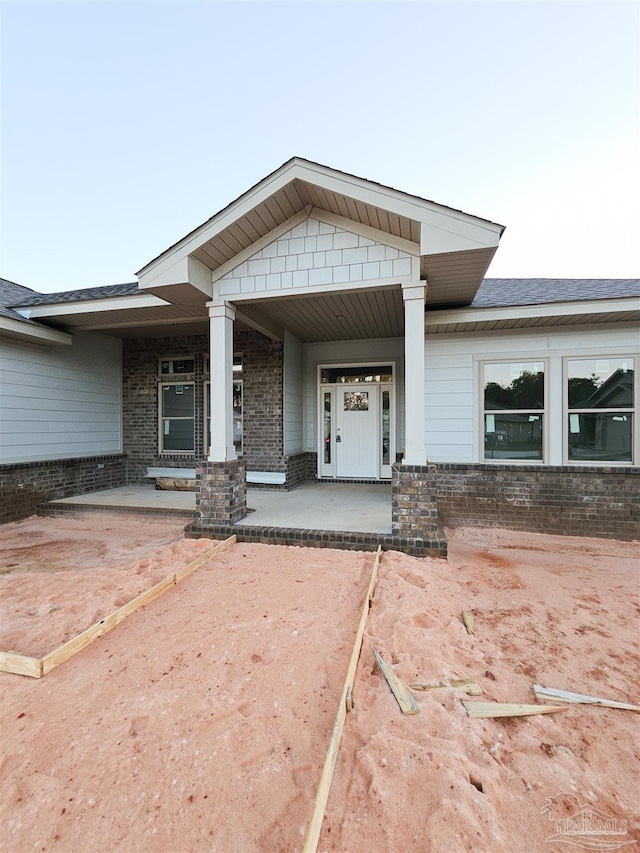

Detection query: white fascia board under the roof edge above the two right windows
xmin=425 ymin=296 xmax=640 ymax=328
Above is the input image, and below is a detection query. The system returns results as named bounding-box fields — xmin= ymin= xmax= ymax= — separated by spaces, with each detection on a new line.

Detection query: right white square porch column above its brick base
xmin=402 ymin=282 xmax=427 ymax=465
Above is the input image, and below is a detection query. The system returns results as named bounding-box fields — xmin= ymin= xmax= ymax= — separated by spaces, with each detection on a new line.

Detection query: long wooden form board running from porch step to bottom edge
xmin=302 ymin=546 xmax=382 ymax=853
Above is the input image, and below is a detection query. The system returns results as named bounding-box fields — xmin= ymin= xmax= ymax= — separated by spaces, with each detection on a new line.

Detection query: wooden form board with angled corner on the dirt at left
xmin=0 ymin=536 xmax=236 ymax=678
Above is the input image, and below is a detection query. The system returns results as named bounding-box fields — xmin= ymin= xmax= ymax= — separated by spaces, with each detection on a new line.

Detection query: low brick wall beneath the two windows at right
xmin=435 ymin=463 xmax=640 ymax=540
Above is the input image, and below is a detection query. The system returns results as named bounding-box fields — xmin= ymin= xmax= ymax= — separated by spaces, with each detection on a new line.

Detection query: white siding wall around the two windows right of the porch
xmin=425 ymin=324 xmax=640 ymax=465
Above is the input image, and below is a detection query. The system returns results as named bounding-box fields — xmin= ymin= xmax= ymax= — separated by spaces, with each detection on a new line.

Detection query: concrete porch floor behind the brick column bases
xmin=50 ymin=483 xmax=391 ymax=535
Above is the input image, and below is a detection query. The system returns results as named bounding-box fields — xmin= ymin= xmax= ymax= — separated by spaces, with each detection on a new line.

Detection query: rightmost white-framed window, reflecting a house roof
xmin=566 ymin=356 xmax=636 ymax=464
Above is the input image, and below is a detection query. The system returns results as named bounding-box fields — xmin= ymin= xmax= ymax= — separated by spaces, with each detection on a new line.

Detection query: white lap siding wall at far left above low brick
xmin=0 ymin=334 xmax=122 ymax=464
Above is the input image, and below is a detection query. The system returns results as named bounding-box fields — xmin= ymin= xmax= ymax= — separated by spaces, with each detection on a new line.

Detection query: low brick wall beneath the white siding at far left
xmin=0 ymin=455 xmax=126 ymax=524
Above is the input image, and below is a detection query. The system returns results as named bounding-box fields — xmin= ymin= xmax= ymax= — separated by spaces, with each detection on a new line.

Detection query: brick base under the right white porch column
xmin=391 ymin=463 xmax=441 ymax=539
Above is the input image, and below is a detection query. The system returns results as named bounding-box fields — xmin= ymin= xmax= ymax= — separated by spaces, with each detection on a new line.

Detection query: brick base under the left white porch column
xmin=196 ymin=459 xmax=247 ymax=527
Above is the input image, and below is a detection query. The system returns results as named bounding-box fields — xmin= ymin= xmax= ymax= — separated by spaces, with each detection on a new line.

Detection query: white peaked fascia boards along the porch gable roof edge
xmin=137 ymin=158 xmax=503 ymax=286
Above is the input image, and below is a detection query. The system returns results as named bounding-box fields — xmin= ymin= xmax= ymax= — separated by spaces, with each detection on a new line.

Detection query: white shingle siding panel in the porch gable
xmin=220 ymin=219 xmax=412 ymax=298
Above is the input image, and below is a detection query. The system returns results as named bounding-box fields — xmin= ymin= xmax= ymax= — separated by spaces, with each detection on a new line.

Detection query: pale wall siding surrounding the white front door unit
xmin=304 ymin=338 xmax=405 ymax=451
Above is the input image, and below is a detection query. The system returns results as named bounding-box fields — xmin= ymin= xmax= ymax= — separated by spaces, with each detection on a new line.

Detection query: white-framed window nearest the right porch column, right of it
xmin=480 ymin=360 xmax=545 ymax=462
